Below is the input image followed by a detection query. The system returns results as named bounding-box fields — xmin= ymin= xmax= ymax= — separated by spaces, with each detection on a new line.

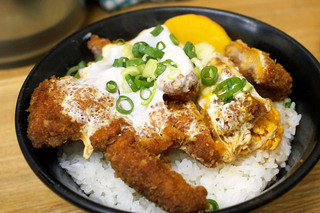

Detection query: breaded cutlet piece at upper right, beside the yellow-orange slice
xmin=225 ymin=40 xmax=292 ymax=101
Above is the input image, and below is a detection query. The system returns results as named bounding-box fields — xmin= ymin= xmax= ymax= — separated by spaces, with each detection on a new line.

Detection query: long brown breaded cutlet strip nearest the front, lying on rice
xmin=106 ymin=131 xmax=209 ymax=212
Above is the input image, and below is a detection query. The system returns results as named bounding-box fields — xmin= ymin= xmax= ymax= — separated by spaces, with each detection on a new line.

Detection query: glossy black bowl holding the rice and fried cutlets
xmin=15 ymin=7 xmax=320 ymax=212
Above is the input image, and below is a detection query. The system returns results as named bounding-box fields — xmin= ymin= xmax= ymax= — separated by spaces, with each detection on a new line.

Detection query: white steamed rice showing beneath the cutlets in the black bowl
xmin=58 ymin=99 xmax=301 ymax=212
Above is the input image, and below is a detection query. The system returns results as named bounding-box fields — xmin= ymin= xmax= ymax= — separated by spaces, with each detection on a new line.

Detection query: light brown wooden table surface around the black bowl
xmin=0 ymin=0 xmax=320 ymax=213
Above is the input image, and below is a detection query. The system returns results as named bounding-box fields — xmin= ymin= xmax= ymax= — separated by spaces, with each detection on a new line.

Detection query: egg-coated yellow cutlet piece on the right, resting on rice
xmin=198 ymin=52 xmax=283 ymax=163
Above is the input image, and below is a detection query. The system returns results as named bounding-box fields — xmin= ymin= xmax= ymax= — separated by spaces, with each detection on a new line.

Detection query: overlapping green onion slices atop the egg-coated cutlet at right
xmin=214 ymin=77 xmax=248 ymax=102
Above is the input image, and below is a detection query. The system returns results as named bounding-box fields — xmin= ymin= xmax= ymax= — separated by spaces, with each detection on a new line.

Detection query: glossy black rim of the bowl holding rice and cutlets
xmin=15 ymin=6 xmax=320 ymax=212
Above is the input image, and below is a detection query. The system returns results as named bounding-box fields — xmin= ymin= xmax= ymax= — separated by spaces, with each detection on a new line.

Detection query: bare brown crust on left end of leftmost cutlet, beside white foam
xmin=27 ymin=77 xmax=82 ymax=148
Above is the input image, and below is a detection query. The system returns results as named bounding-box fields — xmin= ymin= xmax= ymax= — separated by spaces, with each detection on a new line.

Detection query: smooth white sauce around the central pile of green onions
xmin=75 ymin=25 xmax=193 ymax=132
